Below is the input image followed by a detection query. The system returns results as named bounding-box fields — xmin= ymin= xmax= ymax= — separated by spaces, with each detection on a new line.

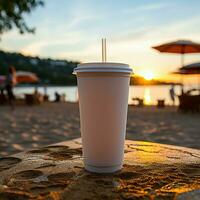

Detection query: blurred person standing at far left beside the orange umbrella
xmin=5 ymin=66 xmax=17 ymax=110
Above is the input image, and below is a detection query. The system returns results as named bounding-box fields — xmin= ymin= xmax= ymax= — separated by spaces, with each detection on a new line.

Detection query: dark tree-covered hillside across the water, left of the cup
xmin=0 ymin=51 xmax=78 ymax=85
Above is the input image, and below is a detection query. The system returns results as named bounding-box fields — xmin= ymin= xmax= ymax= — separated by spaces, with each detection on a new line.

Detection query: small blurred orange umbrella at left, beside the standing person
xmin=16 ymin=71 xmax=39 ymax=83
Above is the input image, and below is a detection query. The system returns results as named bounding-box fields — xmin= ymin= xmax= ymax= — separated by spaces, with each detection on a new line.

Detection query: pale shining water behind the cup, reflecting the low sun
xmin=14 ymin=85 xmax=197 ymax=105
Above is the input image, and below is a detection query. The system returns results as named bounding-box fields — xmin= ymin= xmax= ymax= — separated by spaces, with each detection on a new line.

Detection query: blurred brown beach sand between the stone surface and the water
xmin=0 ymin=103 xmax=200 ymax=156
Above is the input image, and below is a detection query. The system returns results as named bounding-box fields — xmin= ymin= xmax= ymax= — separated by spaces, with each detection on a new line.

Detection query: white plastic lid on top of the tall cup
xmin=73 ymin=62 xmax=133 ymax=74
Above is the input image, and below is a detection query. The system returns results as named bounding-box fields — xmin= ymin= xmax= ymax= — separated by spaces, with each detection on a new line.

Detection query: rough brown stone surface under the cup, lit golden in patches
xmin=0 ymin=139 xmax=200 ymax=200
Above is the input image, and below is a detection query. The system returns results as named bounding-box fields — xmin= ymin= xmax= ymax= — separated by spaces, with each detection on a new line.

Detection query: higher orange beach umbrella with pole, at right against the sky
xmin=152 ymin=40 xmax=200 ymax=67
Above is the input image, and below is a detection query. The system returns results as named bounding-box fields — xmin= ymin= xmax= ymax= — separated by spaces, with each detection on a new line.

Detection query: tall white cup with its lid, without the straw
xmin=74 ymin=63 xmax=132 ymax=173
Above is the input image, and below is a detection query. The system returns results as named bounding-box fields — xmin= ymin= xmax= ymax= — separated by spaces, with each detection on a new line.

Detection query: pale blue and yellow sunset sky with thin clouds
xmin=1 ymin=0 xmax=200 ymax=78
